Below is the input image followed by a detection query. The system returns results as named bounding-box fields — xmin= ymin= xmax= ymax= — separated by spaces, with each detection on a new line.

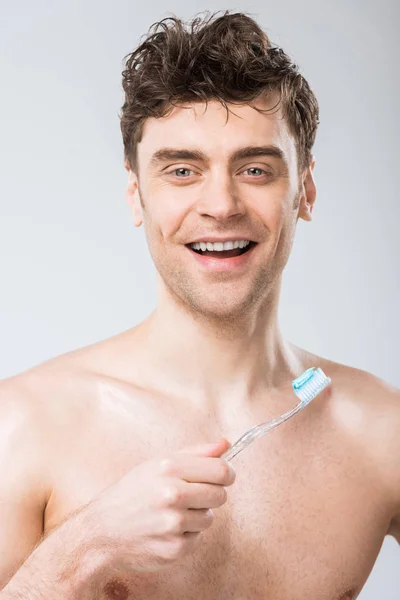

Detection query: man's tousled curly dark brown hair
xmin=120 ymin=10 xmax=319 ymax=172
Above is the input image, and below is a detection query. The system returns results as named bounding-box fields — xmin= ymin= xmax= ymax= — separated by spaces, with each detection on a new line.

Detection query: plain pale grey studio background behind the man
xmin=0 ymin=0 xmax=400 ymax=600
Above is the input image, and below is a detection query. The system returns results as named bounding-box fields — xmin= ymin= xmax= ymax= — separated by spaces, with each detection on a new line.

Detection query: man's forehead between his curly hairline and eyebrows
xmin=138 ymin=97 xmax=296 ymax=167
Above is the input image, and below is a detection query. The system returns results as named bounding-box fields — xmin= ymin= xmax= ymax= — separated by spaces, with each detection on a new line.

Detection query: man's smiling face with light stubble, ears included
xmin=125 ymin=98 xmax=315 ymax=318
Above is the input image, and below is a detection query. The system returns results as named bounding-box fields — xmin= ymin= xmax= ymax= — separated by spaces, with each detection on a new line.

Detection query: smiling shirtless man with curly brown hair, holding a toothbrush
xmin=0 ymin=13 xmax=400 ymax=600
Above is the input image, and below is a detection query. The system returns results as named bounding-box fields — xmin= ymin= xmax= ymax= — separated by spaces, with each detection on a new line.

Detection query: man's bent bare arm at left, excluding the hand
xmin=0 ymin=378 xmax=111 ymax=600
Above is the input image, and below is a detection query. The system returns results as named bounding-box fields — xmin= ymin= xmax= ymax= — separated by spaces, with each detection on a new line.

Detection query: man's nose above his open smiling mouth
xmin=196 ymin=173 xmax=245 ymax=221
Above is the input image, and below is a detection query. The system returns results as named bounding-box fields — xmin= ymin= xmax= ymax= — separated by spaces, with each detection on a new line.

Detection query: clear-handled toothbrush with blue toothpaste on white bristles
xmin=221 ymin=367 xmax=331 ymax=460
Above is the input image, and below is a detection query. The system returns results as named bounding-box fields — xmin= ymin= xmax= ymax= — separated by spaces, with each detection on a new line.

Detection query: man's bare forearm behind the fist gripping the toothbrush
xmin=0 ymin=509 xmax=108 ymax=600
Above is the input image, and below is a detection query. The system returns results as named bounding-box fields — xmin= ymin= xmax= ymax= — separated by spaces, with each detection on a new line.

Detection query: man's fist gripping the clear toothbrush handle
xmin=89 ymin=438 xmax=236 ymax=572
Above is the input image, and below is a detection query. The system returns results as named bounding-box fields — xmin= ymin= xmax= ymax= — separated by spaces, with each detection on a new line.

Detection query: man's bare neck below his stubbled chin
xmin=134 ymin=280 xmax=302 ymax=404
